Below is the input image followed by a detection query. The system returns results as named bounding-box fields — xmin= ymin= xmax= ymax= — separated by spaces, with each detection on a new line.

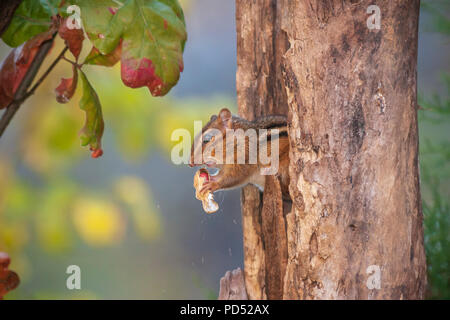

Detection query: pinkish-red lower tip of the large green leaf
xmin=121 ymin=58 xmax=164 ymax=96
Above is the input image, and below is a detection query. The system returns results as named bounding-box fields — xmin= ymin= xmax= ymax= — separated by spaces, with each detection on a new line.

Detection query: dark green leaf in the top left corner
xmin=2 ymin=0 xmax=61 ymax=47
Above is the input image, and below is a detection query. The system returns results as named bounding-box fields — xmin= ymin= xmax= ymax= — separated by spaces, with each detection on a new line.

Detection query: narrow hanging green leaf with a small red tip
xmin=80 ymin=70 xmax=104 ymax=158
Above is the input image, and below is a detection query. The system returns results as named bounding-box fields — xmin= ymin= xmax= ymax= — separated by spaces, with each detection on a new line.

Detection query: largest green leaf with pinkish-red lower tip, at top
xmin=74 ymin=0 xmax=187 ymax=96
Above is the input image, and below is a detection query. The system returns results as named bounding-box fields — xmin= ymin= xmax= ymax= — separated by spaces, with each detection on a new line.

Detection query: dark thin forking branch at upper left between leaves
xmin=0 ymin=33 xmax=68 ymax=138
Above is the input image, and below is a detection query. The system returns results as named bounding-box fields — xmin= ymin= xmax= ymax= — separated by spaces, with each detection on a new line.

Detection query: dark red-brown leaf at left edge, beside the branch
xmin=0 ymin=31 xmax=53 ymax=109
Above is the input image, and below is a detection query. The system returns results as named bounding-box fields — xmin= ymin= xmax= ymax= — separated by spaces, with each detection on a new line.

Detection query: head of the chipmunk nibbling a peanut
xmin=189 ymin=108 xmax=233 ymax=167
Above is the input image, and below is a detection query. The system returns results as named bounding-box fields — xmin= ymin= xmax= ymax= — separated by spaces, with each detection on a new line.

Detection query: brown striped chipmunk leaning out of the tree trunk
xmin=189 ymin=108 xmax=289 ymax=199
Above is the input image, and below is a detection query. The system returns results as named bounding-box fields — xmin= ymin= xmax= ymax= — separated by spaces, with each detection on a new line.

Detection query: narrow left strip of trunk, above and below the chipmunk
xmin=236 ymin=0 xmax=288 ymax=299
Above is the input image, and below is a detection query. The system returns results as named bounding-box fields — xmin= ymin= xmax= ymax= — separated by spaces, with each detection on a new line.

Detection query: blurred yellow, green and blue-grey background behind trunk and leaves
xmin=0 ymin=0 xmax=450 ymax=299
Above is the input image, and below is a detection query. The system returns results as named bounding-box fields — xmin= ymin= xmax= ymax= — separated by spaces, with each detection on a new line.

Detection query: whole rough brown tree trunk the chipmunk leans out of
xmin=236 ymin=0 xmax=426 ymax=299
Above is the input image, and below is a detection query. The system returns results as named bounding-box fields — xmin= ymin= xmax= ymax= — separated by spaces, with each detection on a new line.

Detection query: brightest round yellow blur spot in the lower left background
xmin=73 ymin=199 xmax=125 ymax=246
